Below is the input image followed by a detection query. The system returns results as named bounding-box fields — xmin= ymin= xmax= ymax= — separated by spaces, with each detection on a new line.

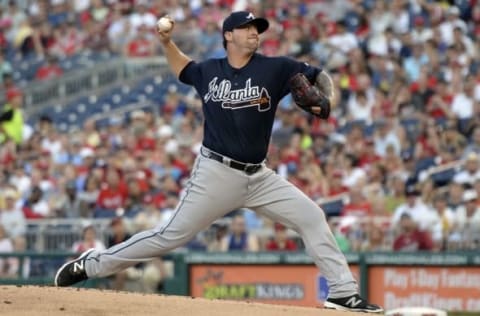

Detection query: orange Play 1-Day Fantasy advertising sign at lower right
xmin=368 ymin=266 xmax=480 ymax=311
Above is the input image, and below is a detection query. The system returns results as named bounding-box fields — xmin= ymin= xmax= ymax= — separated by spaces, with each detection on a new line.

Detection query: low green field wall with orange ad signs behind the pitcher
xmin=0 ymin=252 xmax=480 ymax=315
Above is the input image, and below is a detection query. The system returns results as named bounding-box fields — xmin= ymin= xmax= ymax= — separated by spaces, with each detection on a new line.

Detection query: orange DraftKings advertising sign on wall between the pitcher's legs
xmin=190 ymin=265 xmax=359 ymax=307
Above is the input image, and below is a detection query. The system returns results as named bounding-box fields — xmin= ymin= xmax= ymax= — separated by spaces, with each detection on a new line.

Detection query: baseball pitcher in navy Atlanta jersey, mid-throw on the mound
xmin=55 ymin=11 xmax=383 ymax=313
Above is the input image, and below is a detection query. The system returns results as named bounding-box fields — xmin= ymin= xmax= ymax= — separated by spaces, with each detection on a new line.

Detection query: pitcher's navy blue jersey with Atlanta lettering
xmin=179 ymin=54 xmax=320 ymax=163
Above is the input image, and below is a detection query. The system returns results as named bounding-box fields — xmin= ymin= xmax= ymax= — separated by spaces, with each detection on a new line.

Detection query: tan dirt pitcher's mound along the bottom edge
xmin=0 ymin=286 xmax=364 ymax=316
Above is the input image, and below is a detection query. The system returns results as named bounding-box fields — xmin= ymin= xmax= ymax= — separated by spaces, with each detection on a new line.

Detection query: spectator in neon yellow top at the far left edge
xmin=0 ymin=88 xmax=24 ymax=144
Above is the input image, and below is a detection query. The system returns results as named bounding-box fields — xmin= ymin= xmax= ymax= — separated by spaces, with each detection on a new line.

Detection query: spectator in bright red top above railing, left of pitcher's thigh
xmin=94 ymin=168 xmax=128 ymax=218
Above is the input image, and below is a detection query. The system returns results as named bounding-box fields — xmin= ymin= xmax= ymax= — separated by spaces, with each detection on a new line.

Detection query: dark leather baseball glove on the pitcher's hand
xmin=289 ymin=73 xmax=330 ymax=119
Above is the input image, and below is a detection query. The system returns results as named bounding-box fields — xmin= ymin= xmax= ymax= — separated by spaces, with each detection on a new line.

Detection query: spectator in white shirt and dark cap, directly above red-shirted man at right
xmin=392 ymin=183 xmax=436 ymax=230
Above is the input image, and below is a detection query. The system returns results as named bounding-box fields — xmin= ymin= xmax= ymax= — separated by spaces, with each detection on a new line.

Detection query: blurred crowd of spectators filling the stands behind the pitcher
xmin=0 ymin=0 xmax=480 ymax=276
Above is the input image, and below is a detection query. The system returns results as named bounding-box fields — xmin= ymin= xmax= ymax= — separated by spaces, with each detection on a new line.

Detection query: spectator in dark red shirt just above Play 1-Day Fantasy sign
xmin=393 ymin=213 xmax=434 ymax=251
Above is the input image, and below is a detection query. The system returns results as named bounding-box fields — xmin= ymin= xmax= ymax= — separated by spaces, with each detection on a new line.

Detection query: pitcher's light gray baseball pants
xmin=85 ymin=149 xmax=358 ymax=298
